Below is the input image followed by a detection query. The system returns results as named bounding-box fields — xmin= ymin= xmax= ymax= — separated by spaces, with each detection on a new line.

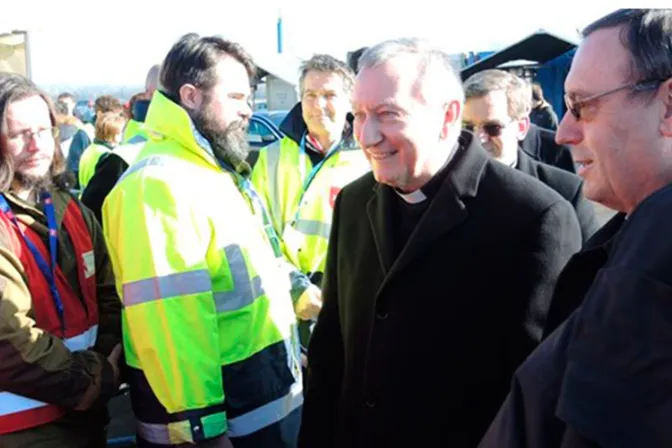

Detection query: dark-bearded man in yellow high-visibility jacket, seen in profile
xmin=103 ymin=34 xmax=308 ymax=448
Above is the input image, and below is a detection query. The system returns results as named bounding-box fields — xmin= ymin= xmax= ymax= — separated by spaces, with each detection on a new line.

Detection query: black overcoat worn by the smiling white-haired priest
xmin=299 ymin=133 xmax=581 ymax=448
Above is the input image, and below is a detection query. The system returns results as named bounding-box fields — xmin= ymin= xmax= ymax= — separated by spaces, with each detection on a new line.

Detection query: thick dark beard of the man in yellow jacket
xmin=191 ymin=105 xmax=250 ymax=171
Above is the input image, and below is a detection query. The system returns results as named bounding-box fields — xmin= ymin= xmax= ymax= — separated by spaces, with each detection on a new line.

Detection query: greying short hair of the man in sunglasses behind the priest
xmin=464 ymin=69 xmax=532 ymax=119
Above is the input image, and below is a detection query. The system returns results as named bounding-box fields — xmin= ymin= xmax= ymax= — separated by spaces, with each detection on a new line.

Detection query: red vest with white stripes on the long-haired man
xmin=0 ymin=200 xmax=98 ymax=434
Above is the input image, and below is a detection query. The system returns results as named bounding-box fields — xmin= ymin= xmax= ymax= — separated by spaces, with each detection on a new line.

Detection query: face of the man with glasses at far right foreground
xmin=556 ymin=28 xmax=669 ymax=212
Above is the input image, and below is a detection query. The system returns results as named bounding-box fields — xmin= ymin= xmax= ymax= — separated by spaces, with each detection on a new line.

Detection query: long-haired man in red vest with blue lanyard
xmin=0 ymin=73 xmax=121 ymax=448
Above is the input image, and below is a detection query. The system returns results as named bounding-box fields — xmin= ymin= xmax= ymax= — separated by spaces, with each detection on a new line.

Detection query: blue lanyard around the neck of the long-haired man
xmin=0 ymin=192 xmax=65 ymax=328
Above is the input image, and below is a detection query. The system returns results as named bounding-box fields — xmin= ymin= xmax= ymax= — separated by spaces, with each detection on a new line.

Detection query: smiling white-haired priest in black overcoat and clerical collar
xmin=299 ymin=39 xmax=581 ymax=448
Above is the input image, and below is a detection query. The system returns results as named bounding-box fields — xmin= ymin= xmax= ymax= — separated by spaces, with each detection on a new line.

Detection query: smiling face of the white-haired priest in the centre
xmin=353 ymin=55 xmax=460 ymax=192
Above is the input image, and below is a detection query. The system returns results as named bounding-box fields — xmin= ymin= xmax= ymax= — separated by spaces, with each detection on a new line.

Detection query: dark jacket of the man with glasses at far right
xmin=480 ymin=185 xmax=672 ymax=448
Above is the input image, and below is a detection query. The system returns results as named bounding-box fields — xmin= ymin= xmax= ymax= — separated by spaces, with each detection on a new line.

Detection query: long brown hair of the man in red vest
xmin=0 ymin=73 xmax=69 ymax=193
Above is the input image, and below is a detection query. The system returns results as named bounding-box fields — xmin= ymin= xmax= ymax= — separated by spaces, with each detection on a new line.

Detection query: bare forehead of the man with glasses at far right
xmin=565 ymin=27 xmax=632 ymax=97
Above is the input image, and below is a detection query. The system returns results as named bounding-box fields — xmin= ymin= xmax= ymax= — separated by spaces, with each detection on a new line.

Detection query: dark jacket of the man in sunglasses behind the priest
xmin=516 ymin=150 xmax=600 ymax=243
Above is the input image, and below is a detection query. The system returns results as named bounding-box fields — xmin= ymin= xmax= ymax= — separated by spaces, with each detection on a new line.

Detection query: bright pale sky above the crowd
xmin=0 ymin=0 xmax=644 ymax=85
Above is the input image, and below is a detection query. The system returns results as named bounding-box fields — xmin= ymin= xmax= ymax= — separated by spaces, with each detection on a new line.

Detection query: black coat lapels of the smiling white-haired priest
xmin=367 ymin=132 xmax=489 ymax=277
